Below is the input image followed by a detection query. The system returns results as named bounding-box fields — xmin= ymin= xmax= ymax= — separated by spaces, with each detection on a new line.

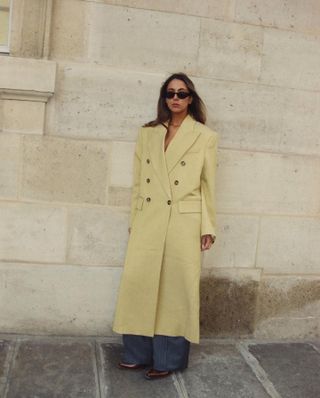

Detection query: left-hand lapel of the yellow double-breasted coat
xmin=148 ymin=125 xmax=171 ymax=198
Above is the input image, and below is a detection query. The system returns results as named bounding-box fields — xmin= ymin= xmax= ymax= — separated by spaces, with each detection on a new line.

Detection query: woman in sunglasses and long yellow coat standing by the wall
xmin=113 ymin=73 xmax=217 ymax=379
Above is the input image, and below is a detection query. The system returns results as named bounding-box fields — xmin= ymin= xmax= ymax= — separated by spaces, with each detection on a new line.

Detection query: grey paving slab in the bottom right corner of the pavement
xmin=249 ymin=343 xmax=320 ymax=398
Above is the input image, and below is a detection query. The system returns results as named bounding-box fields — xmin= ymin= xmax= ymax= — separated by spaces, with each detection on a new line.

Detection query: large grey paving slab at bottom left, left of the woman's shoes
xmin=6 ymin=339 xmax=99 ymax=398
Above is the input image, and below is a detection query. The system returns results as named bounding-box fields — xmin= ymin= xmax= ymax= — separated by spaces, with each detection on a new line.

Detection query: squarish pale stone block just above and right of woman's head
xmin=198 ymin=18 xmax=263 ymax=81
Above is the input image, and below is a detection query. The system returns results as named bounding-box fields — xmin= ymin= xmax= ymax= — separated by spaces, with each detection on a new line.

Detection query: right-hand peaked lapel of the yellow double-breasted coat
xmin=165 ymin=115 xmax=200 ymax=173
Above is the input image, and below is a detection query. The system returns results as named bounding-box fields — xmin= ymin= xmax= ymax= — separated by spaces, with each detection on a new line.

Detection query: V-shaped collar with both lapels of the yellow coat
xmin=148 ymin=115 xmax=200 ymax=197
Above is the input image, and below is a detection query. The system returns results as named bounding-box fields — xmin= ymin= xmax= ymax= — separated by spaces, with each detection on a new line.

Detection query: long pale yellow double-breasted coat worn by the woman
xmin=113 ymin=116 xmax=217 ymax=343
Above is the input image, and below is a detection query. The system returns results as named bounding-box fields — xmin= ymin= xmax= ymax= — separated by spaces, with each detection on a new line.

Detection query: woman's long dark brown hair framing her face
xmin=144 ymin=72 xmax=206 ymax=127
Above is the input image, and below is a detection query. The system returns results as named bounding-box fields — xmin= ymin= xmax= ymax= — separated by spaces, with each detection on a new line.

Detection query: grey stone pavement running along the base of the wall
xmin=0 ymin=335 xmax=320 ymax=398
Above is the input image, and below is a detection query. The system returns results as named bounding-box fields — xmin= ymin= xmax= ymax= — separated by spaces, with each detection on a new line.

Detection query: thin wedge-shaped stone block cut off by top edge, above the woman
xmin=96 ymin=0 xmax=233 ymax=19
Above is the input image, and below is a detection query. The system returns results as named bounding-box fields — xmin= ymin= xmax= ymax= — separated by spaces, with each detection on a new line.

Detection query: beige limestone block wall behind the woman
xmin=0 ymin=0 xmax=320 ymax=338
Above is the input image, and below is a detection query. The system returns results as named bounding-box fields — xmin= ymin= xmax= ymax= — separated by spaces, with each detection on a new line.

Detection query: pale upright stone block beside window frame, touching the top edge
xmin=50 ymin=0 xmax=90 ymax=60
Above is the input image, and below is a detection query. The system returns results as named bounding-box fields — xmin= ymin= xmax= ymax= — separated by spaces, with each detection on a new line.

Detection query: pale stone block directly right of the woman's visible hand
xmin=203 ymin=214 xmax=259 ymax=268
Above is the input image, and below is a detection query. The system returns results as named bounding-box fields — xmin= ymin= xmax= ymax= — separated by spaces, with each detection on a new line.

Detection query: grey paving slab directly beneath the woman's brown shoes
xmin=101 ymin=343 xmax=179 ymax=398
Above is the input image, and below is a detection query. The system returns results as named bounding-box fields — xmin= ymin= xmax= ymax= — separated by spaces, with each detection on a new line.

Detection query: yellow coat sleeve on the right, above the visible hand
xmin=201 ymin=133 xmax=218 ymax=236
